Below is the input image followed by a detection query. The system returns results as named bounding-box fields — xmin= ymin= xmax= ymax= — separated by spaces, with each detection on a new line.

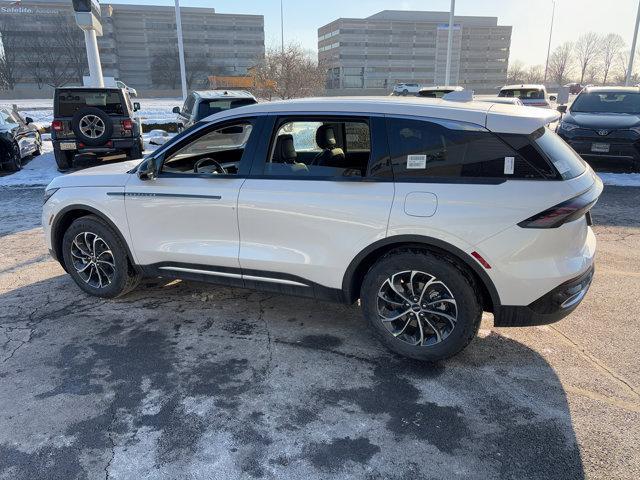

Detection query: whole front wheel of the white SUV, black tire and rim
xmin=62 ymin=215 xmax=141 ymax=298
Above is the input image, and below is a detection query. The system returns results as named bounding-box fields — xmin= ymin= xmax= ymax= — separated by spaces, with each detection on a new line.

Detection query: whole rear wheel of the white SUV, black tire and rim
xmin=361 ymin=250 xmax=482 ymax=361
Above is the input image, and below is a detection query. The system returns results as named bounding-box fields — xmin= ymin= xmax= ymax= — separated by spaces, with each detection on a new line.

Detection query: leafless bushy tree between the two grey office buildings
xmin=252 ymin=43 xmax=326 ymax=99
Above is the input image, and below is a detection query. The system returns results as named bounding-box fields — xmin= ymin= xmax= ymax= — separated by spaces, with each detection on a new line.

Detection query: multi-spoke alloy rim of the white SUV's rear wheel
xmin=377 ymin=270 xmax=458 ymax=347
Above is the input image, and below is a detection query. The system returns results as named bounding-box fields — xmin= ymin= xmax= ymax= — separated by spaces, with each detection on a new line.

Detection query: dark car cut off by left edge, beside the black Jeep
xmin=0 ymin=108 xmax=42 ymax=172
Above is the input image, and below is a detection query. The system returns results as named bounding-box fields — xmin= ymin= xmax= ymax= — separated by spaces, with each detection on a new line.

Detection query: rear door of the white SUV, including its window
xmin=238 ymin=114 xmax=394 ymax=296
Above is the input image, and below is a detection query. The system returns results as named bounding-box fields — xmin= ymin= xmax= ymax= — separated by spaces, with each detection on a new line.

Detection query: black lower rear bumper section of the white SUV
xmin=494 ymin=265 xmax=594 ymax=327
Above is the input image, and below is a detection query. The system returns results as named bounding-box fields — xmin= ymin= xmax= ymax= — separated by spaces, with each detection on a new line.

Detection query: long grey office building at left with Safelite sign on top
xmin=0 ymin=0 xmax=264 ymax=93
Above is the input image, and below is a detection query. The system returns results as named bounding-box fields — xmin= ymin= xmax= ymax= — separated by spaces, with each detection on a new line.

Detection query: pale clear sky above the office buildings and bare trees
xmin=110 ymin=0 xmax=639 ymax=64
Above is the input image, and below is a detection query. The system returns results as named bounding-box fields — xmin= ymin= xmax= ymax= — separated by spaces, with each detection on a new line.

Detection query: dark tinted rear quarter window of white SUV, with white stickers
xmin=387 ymin=119 xmax=544 ymax=181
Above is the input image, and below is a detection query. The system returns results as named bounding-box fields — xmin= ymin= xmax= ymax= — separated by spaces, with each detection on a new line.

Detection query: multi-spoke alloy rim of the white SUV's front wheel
xmin=71 ymin=232 xmax=116 ymax=288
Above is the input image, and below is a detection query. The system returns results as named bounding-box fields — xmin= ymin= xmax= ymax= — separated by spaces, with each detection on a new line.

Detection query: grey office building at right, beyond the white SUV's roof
xmin=318 ymin=10 xmax=511 ymax=94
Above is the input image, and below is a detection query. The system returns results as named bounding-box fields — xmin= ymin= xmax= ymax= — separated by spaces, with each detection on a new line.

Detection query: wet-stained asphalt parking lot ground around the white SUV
xmin=0 ymin=187 xmax=640 ymax=480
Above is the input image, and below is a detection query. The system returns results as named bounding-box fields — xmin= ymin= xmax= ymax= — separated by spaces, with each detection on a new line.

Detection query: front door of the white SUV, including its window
xmin=124 ymin=118 xmax=260 ymax=283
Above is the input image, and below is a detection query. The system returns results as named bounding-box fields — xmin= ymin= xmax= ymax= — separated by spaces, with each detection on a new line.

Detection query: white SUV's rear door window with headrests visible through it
xmin=263 ymin=118 xmax=371 ymax=178
